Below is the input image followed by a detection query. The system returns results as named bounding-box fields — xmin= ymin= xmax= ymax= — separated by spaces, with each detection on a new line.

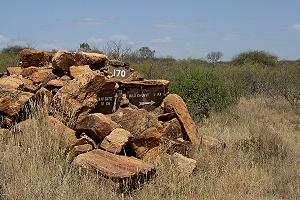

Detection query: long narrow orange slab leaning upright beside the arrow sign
xmin=163 ymin=94 xmax=201 ymax=144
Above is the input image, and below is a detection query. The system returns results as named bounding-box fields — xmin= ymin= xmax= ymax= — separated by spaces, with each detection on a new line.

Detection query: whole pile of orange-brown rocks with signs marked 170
xmin=0 ymin=49 xmax=222 ymax=189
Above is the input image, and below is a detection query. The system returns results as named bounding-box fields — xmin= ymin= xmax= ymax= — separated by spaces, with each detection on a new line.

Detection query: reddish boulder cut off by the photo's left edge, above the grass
xmin=0 ymin=87 xmax=34 ymax=126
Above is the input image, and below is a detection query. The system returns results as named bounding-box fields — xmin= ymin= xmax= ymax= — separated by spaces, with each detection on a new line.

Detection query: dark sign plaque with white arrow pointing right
xmin=126 ymin=85 xmax=166 ymax=111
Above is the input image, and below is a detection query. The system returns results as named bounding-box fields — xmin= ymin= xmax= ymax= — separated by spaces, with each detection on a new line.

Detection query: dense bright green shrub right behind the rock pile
xmin=170 ymin=69 xmax=239 ymax=120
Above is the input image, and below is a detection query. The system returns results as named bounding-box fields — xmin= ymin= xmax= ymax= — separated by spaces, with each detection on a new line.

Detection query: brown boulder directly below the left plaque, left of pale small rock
xmin=75 ymin=113 xmax=120 ymax=143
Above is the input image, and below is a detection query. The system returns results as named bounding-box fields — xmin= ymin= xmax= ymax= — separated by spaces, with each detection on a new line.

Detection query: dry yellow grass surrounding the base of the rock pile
xmin=0 ymin=98 xmax=300 ymax=200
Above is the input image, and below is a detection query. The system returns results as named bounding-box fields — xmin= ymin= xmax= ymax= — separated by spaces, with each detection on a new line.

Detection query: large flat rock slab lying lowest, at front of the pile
xmin=72 ymin=149 xmax=154 ymax=180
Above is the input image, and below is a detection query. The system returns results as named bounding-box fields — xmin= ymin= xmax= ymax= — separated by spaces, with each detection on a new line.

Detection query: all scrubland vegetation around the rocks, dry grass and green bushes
xmin=0 ymin=46 xmax=300 ymax=200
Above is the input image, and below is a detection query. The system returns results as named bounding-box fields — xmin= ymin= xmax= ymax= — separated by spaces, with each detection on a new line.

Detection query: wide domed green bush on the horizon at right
xmin=232 ymin=50 xmax=278 ymax=66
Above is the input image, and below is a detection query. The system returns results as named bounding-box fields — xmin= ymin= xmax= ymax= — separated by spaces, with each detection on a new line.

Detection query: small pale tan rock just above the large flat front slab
xmin=100 ymin=128 xmax=132 ymax=154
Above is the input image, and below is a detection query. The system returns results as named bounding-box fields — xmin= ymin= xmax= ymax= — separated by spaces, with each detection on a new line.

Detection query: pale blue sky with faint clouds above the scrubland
xmin=0 ymin=0 xmax=300 ymax=60
